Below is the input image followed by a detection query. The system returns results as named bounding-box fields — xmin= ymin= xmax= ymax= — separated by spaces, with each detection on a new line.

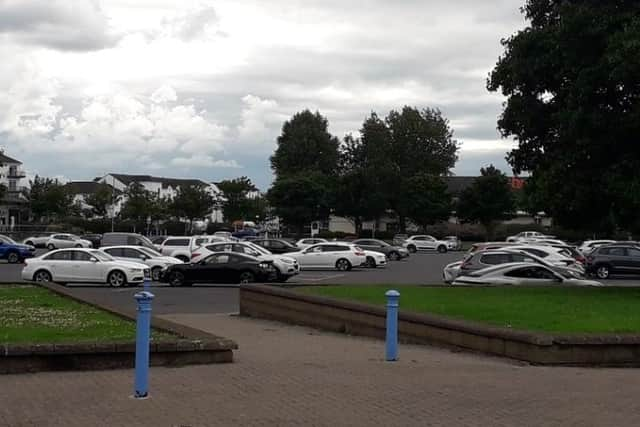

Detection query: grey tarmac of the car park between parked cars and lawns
xmin=5 ymin=250 xmax=640 ymax=314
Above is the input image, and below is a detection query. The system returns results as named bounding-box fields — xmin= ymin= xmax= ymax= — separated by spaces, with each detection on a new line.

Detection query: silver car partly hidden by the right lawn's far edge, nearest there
xmin=453 ymin=262 xmax=602 ymax=286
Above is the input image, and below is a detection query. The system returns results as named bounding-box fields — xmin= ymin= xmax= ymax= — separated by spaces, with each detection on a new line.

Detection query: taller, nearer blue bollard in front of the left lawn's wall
xmin=134 ymin=291 xmax=154 ymax=399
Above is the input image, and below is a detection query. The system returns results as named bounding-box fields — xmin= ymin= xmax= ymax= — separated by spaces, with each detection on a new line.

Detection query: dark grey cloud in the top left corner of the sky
xmin=0 ymin=0 xmax=119 ymax=51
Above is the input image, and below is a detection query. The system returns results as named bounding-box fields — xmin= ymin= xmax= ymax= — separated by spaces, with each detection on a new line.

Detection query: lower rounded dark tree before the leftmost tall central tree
xmin=267 ymin=172 xmax=334 ymax=234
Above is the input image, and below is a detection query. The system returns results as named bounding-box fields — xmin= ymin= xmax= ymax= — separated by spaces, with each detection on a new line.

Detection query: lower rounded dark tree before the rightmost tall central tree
xmin=403 ymin=174 xmax=452 ymax=230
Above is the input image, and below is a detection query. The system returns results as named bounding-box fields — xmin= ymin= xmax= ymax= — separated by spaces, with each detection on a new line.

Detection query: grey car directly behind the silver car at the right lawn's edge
xmin=442 ymin=248 xmax=585 ymax=283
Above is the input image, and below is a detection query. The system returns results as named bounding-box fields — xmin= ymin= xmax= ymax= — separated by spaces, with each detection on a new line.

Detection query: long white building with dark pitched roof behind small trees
xmin=93 ymin=173 xmax=223 ymax=223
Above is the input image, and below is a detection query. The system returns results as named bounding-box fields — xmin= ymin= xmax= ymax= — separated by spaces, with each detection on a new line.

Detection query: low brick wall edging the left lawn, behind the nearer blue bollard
xmin=0 ymin=283 xmax=238 ymax=374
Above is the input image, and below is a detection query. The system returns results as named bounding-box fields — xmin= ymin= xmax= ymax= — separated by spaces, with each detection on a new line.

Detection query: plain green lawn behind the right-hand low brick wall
xmin=298 ymin=286 xmax=640 ymax=333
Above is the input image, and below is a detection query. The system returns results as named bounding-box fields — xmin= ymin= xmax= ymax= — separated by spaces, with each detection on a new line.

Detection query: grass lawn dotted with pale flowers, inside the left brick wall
xmin=0 ymin=285 xmax=172 ymax=344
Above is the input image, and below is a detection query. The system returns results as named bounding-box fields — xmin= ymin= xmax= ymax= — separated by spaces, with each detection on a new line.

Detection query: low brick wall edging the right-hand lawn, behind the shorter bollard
xmin=240 ymin=285 xmax=640 ymax=366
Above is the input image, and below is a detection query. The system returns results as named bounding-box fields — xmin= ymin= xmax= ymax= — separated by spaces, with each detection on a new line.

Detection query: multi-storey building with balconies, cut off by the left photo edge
xmin=0 ymin=150 xmax=29 ymax=229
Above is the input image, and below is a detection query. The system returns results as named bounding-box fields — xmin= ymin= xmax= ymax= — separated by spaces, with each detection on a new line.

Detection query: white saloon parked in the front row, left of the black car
xmin=22 ymin=249 xmax=151 ymax=287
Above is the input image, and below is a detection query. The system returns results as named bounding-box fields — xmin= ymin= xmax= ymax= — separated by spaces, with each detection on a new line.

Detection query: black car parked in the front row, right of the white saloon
xmin=160 ymin=252 xmax=275 ymax=286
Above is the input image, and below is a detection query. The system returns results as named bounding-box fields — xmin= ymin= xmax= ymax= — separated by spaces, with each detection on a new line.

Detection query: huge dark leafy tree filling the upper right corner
xmin=487 ymin=0 xmax=640 ymax=231
